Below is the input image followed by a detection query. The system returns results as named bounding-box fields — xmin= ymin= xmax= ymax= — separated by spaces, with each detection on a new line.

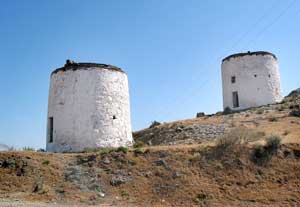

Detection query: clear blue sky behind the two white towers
xmin=0 ymin=0 xmax=300 ymax=148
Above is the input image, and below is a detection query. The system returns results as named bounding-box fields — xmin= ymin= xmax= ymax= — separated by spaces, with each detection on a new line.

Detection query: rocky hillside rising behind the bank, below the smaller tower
xmin=133 ymin=93 xmax=300 ymax=146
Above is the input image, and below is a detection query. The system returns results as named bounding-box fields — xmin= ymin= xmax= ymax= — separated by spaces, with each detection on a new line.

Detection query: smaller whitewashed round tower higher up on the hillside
xmin=222 ymin=51 xmax=282 ymax=110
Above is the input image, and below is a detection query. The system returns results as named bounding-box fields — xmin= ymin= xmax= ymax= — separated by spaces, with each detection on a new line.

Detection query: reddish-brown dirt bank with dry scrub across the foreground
xmin=0 ymin=144 xmax=300 ymax=206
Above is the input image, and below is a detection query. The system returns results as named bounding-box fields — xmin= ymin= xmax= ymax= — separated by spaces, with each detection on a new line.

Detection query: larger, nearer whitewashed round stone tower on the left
xmin=46 ymin=60 xmax=132 ymax=152
